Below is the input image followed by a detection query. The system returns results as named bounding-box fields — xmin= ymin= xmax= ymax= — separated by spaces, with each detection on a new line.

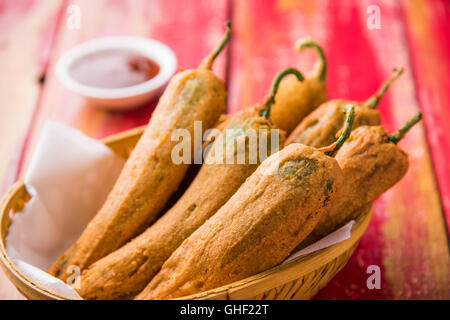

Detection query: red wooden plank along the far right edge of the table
xmin=403 ymin=0 xmax=450 ymax=233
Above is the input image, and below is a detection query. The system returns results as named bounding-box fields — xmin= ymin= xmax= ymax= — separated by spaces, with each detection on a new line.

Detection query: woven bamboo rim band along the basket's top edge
xmin=0 ymin=126 xmax=371 ymax=300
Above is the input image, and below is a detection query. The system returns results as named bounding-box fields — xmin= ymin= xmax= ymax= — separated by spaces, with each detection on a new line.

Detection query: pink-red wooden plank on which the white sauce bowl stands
xmin=19 ymin=0 xmax=227 ymax=175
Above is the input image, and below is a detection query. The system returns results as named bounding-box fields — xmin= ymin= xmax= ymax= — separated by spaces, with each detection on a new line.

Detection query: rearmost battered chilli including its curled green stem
xmin=270 ymin=38 xmax=327 ymax=134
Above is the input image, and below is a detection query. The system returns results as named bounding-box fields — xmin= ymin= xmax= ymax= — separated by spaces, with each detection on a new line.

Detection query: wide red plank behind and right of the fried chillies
xmin=229 ymin=0 xmax=450 ymax=299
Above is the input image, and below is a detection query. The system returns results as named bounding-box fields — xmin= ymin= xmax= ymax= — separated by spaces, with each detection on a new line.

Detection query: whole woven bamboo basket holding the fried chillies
xmin=0 ymin=127 xmax=371 ymax=300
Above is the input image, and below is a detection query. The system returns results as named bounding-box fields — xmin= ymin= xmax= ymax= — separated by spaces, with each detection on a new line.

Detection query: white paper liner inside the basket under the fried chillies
xmin=6 ymin=121 xmax=354 ymax=299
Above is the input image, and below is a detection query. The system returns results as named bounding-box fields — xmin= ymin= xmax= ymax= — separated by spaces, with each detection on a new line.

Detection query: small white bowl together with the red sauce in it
xmin=55 ymin=36 xmax=177 ymax=110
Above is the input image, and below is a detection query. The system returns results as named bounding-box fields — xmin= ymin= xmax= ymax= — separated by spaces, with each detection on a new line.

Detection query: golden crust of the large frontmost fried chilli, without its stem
xmin=137 ymin=144 xmax=342 ymax=299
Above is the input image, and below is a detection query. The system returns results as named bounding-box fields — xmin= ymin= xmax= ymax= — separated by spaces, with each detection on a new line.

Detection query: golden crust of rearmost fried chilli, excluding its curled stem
xmin=270 ymin=76 xmax=327 ymax=134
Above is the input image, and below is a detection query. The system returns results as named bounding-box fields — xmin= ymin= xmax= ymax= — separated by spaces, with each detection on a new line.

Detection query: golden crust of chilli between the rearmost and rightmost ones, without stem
xmin=286 ymin=100 xmax=380 ymax=148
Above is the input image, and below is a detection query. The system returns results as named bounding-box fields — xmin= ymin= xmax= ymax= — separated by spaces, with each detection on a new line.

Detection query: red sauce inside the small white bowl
xmin=69 ymin=49 xmax=159 ymax=89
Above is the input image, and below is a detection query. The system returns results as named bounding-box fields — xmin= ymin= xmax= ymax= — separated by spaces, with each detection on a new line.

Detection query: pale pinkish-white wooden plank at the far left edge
xmin=0 ymin=0 xmax=65 ymax=299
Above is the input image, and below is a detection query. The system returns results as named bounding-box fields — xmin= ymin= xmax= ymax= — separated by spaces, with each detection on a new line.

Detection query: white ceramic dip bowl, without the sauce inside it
xmin=56 ymin=37 xmax=177 ymax=109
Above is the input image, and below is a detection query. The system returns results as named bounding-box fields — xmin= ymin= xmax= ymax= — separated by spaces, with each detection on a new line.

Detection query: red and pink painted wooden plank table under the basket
xmin=0 ymin=0 xmax=450 ymax=299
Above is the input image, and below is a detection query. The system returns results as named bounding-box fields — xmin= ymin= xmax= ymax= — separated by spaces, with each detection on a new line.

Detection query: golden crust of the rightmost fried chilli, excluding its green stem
xmin=301 ymin=126 xmax=409 ymax=247
